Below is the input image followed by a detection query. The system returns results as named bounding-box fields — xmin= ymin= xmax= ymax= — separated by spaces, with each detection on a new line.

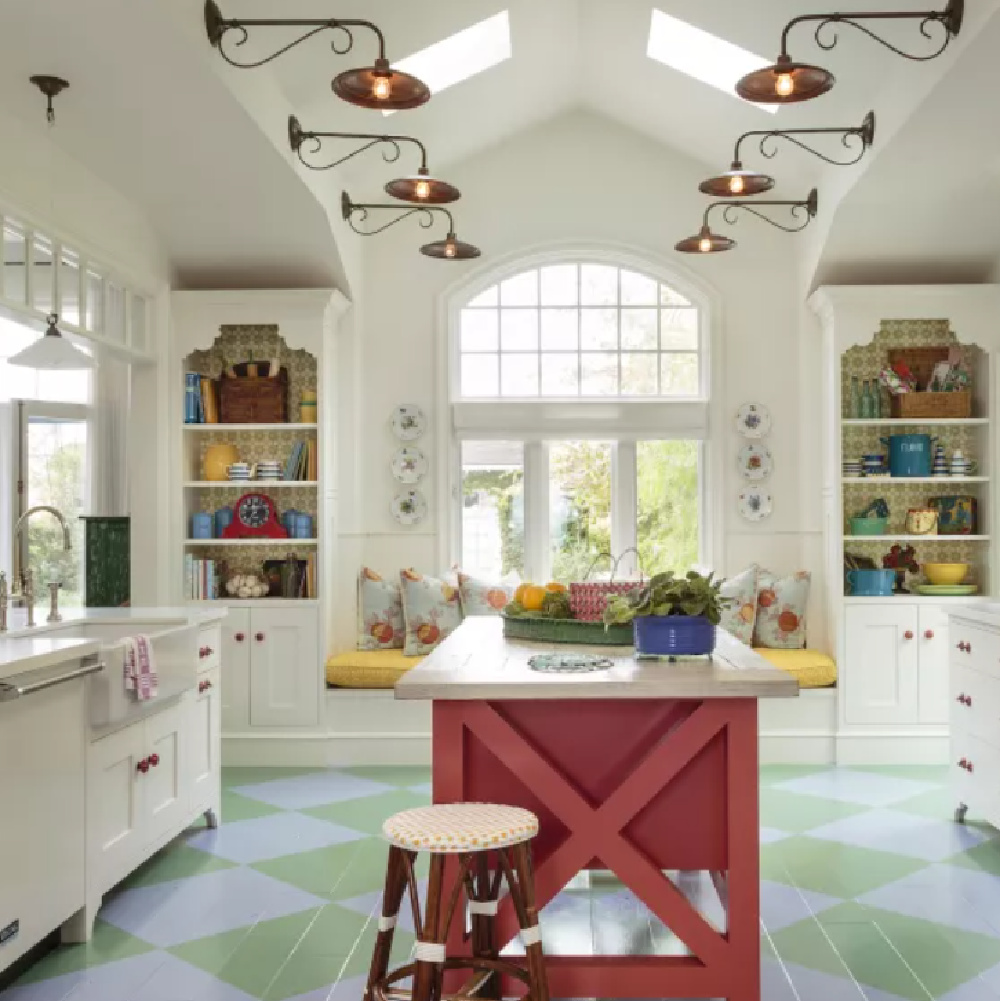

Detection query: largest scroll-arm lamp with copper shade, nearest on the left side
xmin=204 ymin=0 xmax=430 ymax=111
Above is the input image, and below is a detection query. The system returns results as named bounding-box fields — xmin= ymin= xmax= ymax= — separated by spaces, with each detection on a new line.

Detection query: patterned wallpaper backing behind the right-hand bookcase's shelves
xmin=841 ymin=319 xmax=989 ymax=587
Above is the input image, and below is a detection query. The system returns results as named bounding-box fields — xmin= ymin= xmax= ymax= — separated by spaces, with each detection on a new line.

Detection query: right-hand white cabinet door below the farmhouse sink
xmin=140 ymin=704 xmax=190 ymax=844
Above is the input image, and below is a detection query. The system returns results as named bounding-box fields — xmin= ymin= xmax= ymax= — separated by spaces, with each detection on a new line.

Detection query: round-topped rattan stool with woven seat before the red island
xmin=364 ymin=803 xmax=549 ymax=1001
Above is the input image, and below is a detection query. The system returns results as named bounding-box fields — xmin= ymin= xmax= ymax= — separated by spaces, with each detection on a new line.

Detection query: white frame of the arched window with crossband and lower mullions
xmin=436 ymin=243 xmax=725 ymax=579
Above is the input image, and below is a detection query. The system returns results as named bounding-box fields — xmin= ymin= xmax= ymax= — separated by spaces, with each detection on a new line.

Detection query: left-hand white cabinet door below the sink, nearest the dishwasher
xmin=87 ymin=723 xmax=148 ymax=893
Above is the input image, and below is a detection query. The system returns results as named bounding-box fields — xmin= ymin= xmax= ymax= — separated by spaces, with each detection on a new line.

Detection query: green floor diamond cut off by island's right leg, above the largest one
xmin=761 ymin=837 xmax=928 ymax=899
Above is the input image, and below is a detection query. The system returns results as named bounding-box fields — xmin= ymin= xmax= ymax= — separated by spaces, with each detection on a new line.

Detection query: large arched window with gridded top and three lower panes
xmin=447 ymin=259 xmax=709 ymax=581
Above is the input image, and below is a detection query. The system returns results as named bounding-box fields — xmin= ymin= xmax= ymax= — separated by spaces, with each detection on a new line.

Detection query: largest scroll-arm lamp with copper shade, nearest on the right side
xmin=736 ymin=0 xmax=965 ymax=104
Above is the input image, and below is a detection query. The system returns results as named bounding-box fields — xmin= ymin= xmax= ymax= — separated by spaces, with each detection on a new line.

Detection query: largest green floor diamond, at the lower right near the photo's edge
xmin=774 ymin=903 xmax=1000 ymax=1001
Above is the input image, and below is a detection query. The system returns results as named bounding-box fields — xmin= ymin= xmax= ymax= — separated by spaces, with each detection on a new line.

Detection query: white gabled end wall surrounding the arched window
xmin=334 ymin=112 xmax=825 ymax=649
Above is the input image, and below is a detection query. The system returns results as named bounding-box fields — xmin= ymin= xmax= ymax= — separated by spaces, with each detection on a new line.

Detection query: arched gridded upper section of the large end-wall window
xmin=458 ymin=261 xmax=702 ymax=399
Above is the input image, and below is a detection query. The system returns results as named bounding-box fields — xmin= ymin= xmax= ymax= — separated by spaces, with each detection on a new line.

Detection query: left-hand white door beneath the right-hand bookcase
xmin=841 ymin=600 xmax=920 ymax=724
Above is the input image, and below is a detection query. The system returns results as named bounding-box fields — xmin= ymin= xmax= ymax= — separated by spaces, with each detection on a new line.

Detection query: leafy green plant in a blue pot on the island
xmin=605 ymin=571 xmax=731 ymax=657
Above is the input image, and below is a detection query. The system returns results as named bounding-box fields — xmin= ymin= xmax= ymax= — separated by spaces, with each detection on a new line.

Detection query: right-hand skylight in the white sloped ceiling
xmin=648 ymin=8 xmax=779 ymax=114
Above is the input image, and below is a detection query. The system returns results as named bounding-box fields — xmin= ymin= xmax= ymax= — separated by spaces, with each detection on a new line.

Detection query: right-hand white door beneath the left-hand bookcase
xmin=250 ymin=605 xmax=320 ymax=727
